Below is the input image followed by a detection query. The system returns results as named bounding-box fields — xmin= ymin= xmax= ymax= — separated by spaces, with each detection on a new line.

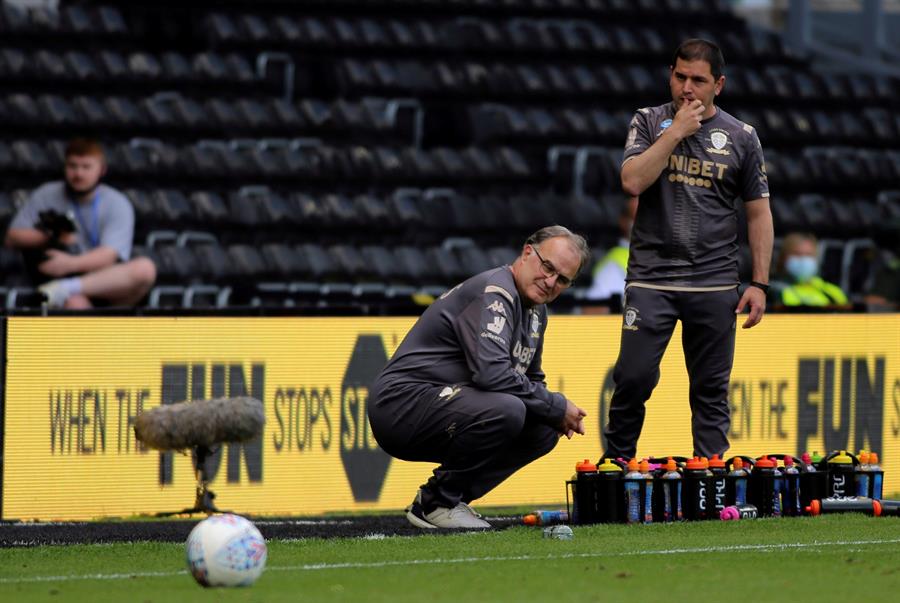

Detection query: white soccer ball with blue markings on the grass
xmin=186 ymin=513 xmax=267 ymax=586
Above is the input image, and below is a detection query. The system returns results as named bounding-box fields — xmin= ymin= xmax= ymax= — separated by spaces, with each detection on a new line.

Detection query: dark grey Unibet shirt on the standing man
xmin=624 ymin=103 xmax=769 ymax=287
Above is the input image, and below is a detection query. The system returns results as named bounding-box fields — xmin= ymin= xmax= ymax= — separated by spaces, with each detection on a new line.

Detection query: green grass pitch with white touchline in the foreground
xmin=0 ymin=514 xmax=900 ymax=603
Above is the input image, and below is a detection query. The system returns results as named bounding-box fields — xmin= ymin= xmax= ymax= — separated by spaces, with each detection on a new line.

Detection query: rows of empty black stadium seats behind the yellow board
xmin=0 ymin=0 xmax=900 ymax=310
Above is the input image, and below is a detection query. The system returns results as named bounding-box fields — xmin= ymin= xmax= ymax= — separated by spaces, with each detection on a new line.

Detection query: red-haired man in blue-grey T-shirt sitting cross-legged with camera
xmin=6 ymin=139 xmax=156 ymax=309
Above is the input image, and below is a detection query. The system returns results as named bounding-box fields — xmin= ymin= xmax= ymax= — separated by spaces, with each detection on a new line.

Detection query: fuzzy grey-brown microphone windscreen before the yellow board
xmin=134 ymin=396 xmax=266 ymax=450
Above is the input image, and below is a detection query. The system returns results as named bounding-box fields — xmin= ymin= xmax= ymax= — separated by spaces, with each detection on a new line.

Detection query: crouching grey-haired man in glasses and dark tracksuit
xmin=368 ymin=226 xmax=590 ymax=528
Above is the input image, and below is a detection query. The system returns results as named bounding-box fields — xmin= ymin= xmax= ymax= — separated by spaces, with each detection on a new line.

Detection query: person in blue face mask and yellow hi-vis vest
xmin=772 ymin=233 xmax=849 ymax=307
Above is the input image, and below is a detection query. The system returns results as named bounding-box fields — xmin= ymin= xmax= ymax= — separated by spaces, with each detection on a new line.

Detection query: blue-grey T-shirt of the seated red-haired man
xmin=9 ymin=180 xmax=134 ymax=261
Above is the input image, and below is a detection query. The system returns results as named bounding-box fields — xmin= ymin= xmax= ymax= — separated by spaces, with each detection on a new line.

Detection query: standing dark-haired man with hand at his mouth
xmin=604 ymin=39 xmax=773 ymax=458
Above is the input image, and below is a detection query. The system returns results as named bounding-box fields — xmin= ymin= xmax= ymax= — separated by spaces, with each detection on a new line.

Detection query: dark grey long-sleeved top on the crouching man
xmin=374 ymin=266 xmax=566 ymax=426
